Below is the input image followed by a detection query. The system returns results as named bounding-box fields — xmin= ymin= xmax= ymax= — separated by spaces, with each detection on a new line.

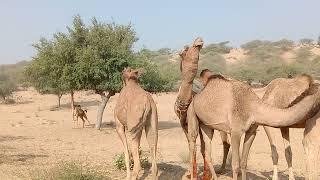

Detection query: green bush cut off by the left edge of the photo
xmin=0 ymin=73 xmax=17 ymax=101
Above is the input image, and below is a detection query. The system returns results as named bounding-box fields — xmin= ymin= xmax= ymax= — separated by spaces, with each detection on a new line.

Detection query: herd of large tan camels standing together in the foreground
xmin=114 ymin=38 xmax=320 ymax=180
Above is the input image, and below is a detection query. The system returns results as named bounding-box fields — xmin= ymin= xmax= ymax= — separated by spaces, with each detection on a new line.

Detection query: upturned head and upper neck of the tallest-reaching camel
xmin=179 ymin=38 xmax=203 ymax=82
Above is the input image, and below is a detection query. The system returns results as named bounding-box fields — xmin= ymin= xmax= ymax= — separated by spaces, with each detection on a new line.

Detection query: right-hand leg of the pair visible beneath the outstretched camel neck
xmin=280 ymin=128 xmax=294 ymax=180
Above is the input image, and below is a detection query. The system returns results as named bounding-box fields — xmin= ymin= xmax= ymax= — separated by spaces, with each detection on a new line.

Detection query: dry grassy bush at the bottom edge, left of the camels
xmin=32 ymin=162 xmax=111 ymax=180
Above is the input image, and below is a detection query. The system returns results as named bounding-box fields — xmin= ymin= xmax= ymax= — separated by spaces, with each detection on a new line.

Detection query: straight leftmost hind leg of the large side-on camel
xmin=187 ymin=104 xmax=199 ymax=180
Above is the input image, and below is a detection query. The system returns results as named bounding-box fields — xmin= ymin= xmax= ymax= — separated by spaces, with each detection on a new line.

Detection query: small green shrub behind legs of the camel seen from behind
xmin=113 ymin=149 xmax=150 ymax=170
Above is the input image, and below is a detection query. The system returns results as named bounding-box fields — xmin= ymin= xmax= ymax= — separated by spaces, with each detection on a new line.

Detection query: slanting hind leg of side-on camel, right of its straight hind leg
xmin=200 ymin=124 xmax=218 ymax=180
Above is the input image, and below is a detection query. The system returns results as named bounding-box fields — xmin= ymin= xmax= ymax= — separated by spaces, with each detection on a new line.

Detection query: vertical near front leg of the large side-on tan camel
xmin=231 ymin=132 xmax=241 ymax=180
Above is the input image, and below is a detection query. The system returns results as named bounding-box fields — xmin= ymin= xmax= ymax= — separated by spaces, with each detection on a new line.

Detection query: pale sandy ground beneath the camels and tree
xmin=0 ymin=90 xmax=305 ymax=179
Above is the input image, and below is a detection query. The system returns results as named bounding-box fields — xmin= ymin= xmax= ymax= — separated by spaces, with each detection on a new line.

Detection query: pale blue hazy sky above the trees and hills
xmin=0 ymin=0 xmax=320 ymax=64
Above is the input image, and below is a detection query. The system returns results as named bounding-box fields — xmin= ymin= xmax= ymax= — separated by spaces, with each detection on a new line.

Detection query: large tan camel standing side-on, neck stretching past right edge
xmin=186 ymin=44 xmax=320 ymax=179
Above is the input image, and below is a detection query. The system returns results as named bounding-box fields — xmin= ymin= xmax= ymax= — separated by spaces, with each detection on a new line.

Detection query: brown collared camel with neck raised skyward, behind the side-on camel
xmin=174 ymin=38 xmax=230 ymax=179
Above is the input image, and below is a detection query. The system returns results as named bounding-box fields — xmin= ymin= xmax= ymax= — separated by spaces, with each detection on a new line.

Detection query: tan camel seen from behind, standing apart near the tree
xmin=114 ymin=68 xmax=158 ymax=179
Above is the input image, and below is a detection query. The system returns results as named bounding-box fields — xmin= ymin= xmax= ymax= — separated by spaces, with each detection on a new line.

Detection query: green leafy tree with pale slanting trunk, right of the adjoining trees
xmin=75 ymin=18 xmax=138 ymax=129
